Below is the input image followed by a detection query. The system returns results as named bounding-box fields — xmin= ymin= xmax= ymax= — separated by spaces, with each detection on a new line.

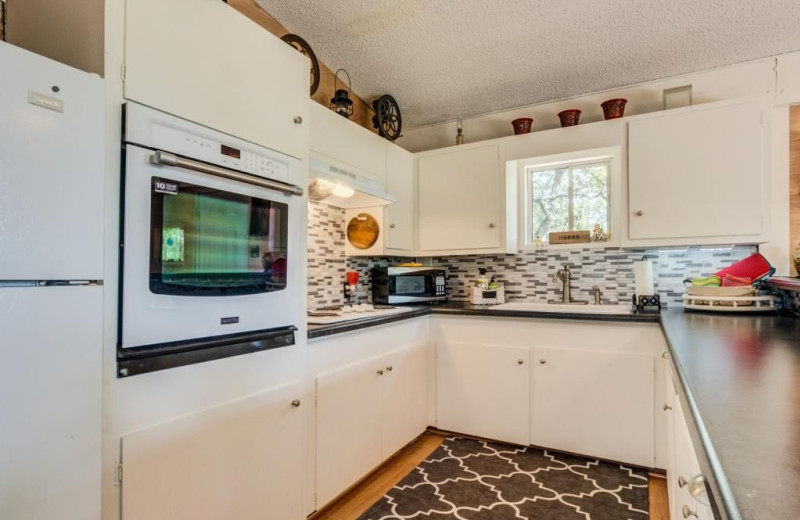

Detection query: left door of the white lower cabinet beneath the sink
xmin=436 ymin=343 xmax=530 ymax=445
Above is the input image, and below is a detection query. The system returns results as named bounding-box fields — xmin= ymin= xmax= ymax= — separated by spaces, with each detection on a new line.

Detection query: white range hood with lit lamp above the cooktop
xmin=308 ymin=152 xmax=396 ymax=209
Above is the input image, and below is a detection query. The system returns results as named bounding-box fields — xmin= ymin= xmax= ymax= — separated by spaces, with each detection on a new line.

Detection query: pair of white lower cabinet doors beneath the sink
xmin=436 ymin=341 xmax=655 ymax=467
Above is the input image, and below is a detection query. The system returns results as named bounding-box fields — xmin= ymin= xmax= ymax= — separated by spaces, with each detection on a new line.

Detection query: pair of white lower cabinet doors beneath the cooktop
xmin=316 ymin=344 xmax=428 ymax=508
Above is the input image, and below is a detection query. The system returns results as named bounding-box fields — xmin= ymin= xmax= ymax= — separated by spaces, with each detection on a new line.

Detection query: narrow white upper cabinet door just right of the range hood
xmin=386 ymin=144 xmax=415 ymax=251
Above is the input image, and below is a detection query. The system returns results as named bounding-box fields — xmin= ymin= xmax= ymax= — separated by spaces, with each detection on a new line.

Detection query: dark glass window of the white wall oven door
xmin=150 ymin=177 xmax=289 ymax=296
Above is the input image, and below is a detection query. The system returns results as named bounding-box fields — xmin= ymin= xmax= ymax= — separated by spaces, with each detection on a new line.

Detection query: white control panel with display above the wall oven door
xmin=153 ymin=124 xmax=291 ymax=182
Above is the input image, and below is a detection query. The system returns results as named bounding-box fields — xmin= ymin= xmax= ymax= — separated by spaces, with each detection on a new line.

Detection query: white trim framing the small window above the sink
xmin=515 ymin=146 xmax=622 ymax=251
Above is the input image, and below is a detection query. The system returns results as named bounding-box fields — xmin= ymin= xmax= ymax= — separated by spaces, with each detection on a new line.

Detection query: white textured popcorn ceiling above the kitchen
xmin=257 ymin=0 xmax=800 ymax=128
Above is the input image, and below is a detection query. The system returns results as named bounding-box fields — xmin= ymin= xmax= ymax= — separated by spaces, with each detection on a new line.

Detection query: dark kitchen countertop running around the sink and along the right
xmin=309 ymin=302 xmax=800 ymax=520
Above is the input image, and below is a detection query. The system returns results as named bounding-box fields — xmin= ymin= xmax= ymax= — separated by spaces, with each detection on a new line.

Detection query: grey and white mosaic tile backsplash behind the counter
xmin=308 ymin=202 xmax=757 ymax=309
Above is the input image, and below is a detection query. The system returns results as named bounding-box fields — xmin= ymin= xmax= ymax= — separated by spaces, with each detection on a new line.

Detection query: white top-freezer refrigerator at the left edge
xmin=0 ymin=42 xmax=105 ymax=520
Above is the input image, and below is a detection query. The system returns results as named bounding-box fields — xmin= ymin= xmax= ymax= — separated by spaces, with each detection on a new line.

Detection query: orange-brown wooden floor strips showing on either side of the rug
xmin=311 ymin=432 xmax=669 ymax=520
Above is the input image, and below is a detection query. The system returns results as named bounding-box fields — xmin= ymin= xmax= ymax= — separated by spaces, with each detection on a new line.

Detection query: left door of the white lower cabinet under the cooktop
xmin=316 ymin=359 xmax=381 ymax=506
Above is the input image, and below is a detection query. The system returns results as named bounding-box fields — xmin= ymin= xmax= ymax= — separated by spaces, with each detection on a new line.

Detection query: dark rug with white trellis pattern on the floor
xmin=359 ymin=437 xmax=649 ymax=520
